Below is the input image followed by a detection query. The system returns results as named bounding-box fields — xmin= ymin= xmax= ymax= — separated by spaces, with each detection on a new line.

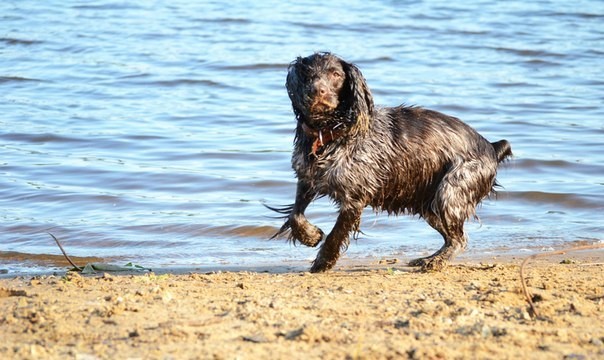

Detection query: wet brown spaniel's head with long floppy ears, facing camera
xmin=285 ymin=53 xmax=373 ymax=136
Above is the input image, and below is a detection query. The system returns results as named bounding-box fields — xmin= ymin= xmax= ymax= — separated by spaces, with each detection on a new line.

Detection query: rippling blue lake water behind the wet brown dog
xmin=0 ymin=0 xmax=604 ymax=274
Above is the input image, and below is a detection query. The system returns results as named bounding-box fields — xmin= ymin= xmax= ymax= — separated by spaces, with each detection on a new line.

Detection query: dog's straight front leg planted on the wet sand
xmin=310 ymin=208 xmax=363 ymax=273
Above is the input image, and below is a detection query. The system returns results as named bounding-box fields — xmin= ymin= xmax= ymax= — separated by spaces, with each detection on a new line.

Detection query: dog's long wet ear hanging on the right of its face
xmin=341 ymin=60 xmax=373 ymax=129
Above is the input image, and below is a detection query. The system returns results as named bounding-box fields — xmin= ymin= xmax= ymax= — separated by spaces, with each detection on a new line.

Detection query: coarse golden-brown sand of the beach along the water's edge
xmin=0 ymin=250 xmax=604 ymax=359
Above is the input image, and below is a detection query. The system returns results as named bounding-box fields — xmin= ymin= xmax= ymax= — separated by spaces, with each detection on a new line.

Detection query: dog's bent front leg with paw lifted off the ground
xmin=284 ymin=181 xmax=325 ymax=247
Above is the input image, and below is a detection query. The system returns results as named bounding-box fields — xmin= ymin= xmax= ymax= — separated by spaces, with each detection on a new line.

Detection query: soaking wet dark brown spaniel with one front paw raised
xmin=267 ymin=52 xmax=512 ymax=273
